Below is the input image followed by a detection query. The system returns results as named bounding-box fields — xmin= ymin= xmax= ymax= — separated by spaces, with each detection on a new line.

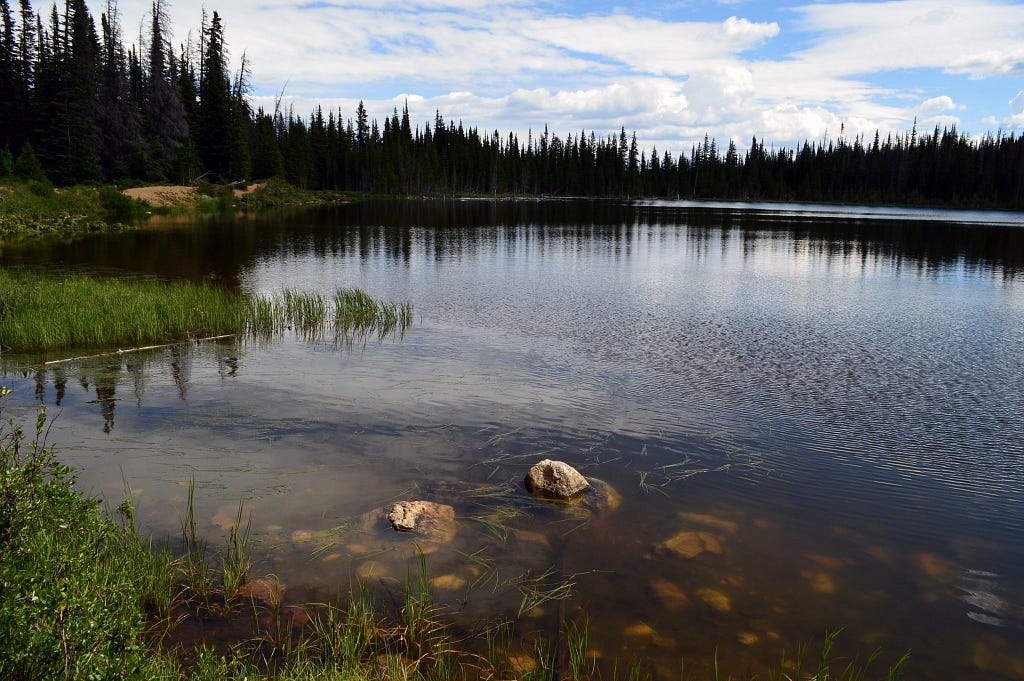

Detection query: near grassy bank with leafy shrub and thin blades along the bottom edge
xmin=0 ymin=399 xmax=904 ymax=681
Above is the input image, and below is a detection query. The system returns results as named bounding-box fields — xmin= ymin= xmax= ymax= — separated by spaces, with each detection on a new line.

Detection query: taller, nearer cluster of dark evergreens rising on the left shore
xmin=0 ymin=0 xmax=252 ymax=184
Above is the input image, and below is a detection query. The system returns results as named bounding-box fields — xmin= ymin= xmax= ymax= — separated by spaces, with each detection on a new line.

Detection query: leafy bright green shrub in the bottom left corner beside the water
xmin=0 ymin=401 xmax=167 ymax=680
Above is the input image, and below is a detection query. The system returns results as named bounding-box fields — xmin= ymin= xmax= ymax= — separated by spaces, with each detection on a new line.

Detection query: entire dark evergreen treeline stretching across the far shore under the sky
xmin=0 ymin=0 xmax=1024 ymax=208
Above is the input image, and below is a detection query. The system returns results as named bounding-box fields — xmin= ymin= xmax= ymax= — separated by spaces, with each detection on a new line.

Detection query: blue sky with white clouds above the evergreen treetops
xmin=101 ymin=0 xmax=1024 ymax=154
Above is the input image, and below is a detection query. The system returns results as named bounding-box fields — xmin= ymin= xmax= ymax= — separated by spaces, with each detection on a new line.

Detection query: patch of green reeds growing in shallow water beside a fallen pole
xmin=0 ymin=270 xmax=412 ymax=352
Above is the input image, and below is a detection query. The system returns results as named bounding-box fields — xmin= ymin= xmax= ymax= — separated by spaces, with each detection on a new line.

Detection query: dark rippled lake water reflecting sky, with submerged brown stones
xmin=0 ymin=201 xmax=1024 ymax=679
